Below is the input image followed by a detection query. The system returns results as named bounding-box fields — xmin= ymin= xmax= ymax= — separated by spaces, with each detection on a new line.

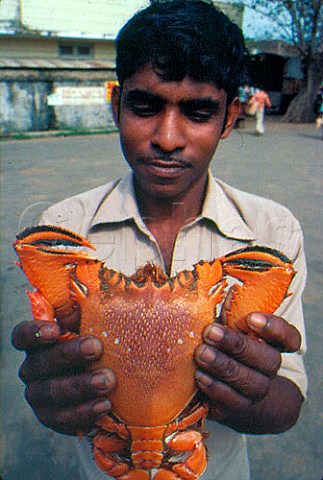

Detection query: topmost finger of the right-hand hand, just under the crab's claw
xmin=247 ymin=312 xmax=301 ymax=352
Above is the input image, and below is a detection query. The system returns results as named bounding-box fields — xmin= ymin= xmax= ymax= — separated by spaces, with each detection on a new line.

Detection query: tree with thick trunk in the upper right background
xmin=241 ymin=0 xmax=323 ymax=123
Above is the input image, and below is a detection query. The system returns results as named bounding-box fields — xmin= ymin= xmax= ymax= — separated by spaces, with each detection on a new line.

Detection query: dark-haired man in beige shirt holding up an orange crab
xmin=13 ymin=0 xmax=306 ymax=480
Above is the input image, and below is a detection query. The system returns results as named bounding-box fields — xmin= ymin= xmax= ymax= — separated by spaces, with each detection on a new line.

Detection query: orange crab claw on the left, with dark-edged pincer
xmin=13 ymin=225 xmax=99 ymax=317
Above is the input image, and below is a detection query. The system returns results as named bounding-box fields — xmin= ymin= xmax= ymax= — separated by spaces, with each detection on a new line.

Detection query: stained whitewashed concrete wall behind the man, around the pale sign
xmin=0 ymin=70 xmax=114 ymax=136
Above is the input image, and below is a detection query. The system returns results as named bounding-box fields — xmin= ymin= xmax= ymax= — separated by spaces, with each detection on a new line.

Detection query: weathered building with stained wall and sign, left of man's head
xmin=0 ymin=0 xmax=146 ymax=135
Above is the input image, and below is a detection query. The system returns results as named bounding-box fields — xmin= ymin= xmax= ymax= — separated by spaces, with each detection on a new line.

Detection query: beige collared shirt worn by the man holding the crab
xmin=42 ymin=173 xmax=307 ymax=480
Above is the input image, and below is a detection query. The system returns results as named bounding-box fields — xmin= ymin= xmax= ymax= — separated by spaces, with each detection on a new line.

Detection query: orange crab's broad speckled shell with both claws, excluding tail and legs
xmin=14 ymin=226 xmax=295 ymax=432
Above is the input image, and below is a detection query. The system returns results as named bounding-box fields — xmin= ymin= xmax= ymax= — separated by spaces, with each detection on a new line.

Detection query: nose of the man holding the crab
xmin=151 ymin=109 xmax=186 ymax=152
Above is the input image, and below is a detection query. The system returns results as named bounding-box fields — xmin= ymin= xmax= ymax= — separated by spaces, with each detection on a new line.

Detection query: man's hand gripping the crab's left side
xmin=12 ymin=322 xmax=115 ymax=435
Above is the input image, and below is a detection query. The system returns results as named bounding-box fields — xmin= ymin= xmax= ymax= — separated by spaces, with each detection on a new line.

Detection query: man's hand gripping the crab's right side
xmin=195 ymin=313 xmax=303 ymax=433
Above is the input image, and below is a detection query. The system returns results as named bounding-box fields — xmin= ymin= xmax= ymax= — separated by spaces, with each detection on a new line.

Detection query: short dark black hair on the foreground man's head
xmin=116 ymin=0 xmax=248 ymax=102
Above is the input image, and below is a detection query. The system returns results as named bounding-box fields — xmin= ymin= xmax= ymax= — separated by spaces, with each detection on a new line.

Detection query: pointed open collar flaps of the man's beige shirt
xmin=91 ymin=172 xmax=255 ymax=241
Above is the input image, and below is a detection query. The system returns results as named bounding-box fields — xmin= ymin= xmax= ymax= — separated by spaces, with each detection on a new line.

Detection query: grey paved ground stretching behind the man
xmin=0 ymin=119 xmax=323 ymax=480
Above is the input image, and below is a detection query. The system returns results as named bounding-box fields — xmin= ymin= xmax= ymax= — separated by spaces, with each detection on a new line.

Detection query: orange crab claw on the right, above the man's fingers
xmin=220 ymin=246 xmax=296 ymax=334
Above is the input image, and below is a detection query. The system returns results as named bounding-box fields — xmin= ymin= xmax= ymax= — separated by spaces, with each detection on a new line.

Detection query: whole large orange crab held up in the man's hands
xmin=14 ymin=226 xmax=295 ymax=480
